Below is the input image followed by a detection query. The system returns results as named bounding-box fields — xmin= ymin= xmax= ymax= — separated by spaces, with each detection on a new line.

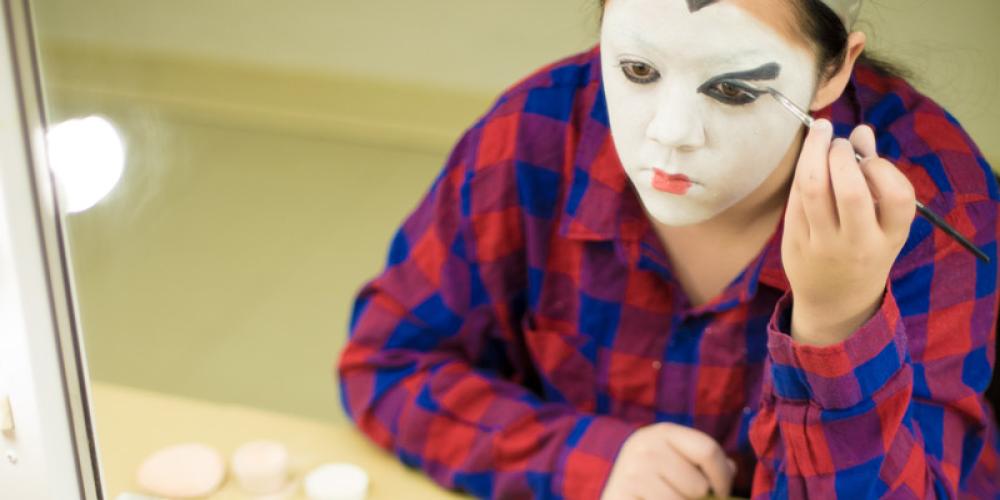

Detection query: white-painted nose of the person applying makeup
xmin=646 ymin=88 xmax=705 ymax=151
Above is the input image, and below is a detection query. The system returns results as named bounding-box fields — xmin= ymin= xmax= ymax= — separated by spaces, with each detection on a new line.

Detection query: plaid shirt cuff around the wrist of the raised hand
xmin=767 ymin=282 xmax=909 ymax=410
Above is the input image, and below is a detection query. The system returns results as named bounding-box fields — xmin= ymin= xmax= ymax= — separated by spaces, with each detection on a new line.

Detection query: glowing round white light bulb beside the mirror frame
xmin=46 ymin=116 xmax=125 ymax=213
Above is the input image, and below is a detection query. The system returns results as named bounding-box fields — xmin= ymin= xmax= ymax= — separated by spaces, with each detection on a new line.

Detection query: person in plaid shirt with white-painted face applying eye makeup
xmin=339 ymin=0 xmax=1000 ymax=499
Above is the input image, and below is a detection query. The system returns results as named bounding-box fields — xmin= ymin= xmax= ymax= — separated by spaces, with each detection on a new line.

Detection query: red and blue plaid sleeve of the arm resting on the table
xmin=338 ymin=119 xmax=635 ymax=498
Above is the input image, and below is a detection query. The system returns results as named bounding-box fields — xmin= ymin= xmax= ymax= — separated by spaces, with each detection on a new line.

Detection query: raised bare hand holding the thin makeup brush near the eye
xmin=782 ymin=119 xmax=915 ymax=346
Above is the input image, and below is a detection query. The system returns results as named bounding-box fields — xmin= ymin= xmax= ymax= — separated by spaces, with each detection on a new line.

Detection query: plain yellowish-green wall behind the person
xmin=33 ymin=0 xmax=1000 ymax=426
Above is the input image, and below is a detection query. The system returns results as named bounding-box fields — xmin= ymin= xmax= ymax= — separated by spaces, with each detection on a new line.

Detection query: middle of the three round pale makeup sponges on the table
xmin=230 ymin=441 xmax=288 ymax=495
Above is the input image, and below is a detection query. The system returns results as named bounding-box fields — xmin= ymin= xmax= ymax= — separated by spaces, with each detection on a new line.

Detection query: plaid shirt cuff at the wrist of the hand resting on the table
xmin=553 ymin=416 xmax=640 ymax=500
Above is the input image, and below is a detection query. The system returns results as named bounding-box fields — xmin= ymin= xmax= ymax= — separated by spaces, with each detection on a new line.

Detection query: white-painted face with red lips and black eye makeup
xmin=601 ymin=0 xmax=816 ymax=226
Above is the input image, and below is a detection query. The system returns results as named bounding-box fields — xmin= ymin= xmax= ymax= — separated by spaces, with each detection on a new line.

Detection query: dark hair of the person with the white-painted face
xmin=599 ymin=0 xmax=912 ymax=78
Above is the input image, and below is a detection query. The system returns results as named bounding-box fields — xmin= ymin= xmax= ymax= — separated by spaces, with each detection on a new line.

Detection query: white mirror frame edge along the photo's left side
xmin=0 ymin=0 xmax=104 ymax=500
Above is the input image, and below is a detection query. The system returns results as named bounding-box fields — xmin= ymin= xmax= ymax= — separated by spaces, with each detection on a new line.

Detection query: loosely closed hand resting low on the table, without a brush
xmin=601 ymin=423 xmax=736 ymax=500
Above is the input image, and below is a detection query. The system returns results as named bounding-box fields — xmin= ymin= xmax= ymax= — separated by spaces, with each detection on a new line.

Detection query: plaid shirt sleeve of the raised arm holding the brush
xmin=750 ymin=155 xmax=998 ymax=498
